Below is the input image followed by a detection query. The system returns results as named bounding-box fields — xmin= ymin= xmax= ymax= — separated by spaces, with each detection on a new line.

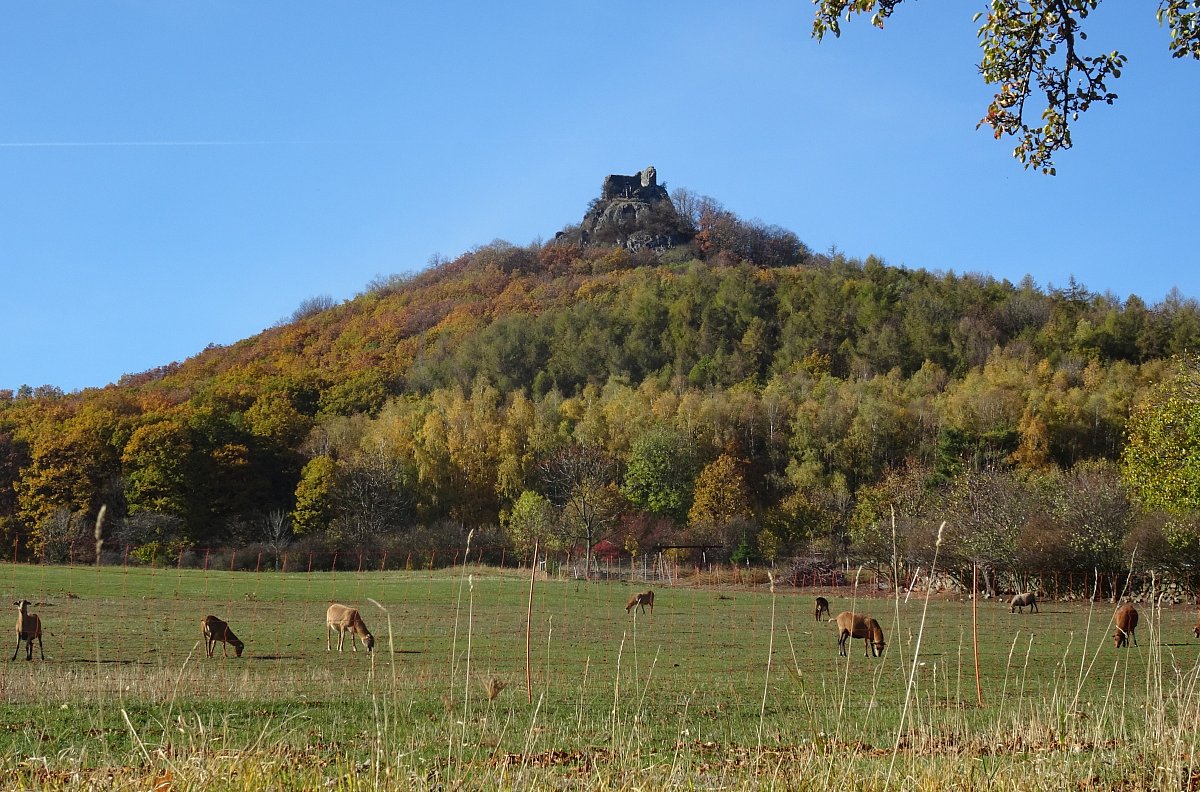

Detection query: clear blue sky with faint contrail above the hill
xmin=0 ymin=0 xmax=1200 ymax=391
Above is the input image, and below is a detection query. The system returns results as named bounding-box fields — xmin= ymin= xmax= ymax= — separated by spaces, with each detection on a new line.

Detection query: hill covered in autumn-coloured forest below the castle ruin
xmin=0 ymin=204 xmax=1200 ymax=580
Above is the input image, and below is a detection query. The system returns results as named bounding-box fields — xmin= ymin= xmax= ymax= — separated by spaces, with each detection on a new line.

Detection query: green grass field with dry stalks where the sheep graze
xmin=0 ymin=564 xmax=1200 ymax=792
